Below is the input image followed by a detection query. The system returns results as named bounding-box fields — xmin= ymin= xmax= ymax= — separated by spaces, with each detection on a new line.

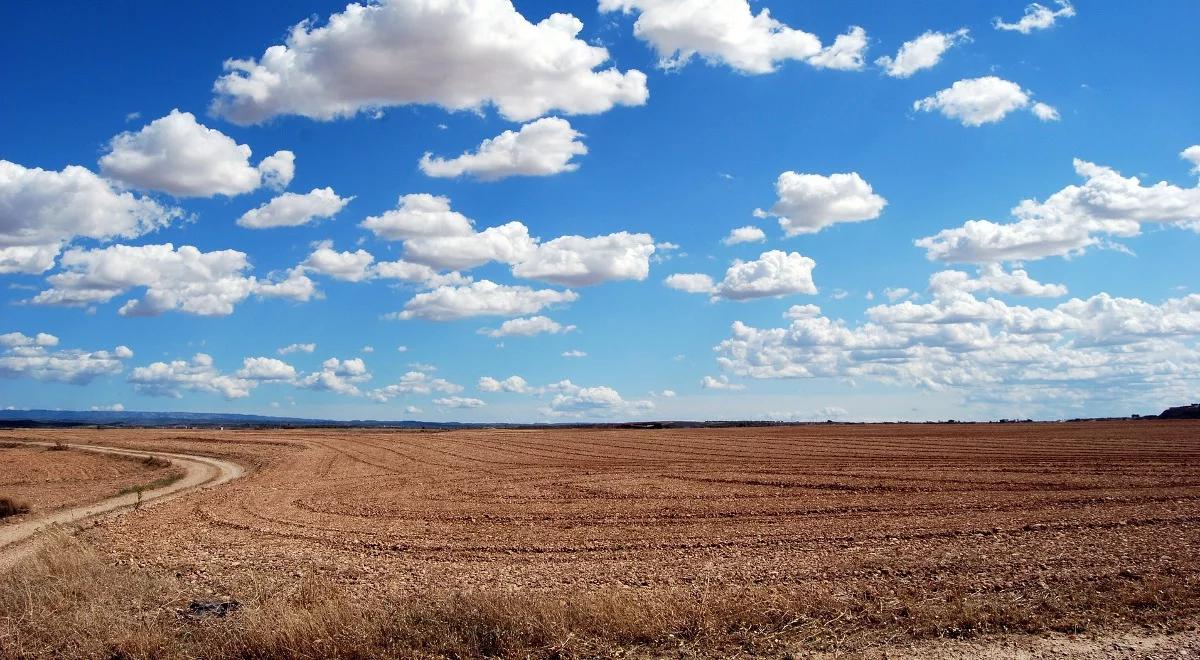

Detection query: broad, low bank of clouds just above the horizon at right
xmin=716 ymin=274 xmax=1200 ymax=406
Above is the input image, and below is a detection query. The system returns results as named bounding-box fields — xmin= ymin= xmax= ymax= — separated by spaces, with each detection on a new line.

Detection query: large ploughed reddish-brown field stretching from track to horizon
xmin=0 ymin=421 xmax=1200 ymax=658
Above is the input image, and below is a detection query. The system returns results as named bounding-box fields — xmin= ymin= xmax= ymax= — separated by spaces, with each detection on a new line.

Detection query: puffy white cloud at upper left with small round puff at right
xmin=100 ymin=109 xmax=294 ymax=197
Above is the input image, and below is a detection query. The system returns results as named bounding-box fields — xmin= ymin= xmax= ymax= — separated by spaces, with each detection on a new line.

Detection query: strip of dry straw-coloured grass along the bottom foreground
xmin=0 ymin=536 xmax=1196 ymax=659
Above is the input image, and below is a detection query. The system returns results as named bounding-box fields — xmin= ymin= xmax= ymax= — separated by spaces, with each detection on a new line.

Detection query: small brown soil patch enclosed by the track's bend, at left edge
xmin=0 ymin=444 xmax=182 ymax=523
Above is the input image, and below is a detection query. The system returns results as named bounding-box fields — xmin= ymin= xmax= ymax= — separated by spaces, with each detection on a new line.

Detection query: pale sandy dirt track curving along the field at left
xmin=0 ymin=443 xmax=246 ymax=569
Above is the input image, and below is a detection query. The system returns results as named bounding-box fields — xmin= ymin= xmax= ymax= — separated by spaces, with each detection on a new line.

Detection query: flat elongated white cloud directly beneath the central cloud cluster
xmin=394 ymin=280 xmax=578 ymax=320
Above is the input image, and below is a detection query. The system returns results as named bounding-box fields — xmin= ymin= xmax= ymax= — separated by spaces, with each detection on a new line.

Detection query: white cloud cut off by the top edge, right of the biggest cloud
xmin=600 ymin=0 xmax=866 ymax=73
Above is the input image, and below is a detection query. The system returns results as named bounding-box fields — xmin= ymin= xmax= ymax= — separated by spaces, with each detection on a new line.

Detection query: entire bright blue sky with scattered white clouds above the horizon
xmin=0 ymin=0 xmax=1200 ymax=421
